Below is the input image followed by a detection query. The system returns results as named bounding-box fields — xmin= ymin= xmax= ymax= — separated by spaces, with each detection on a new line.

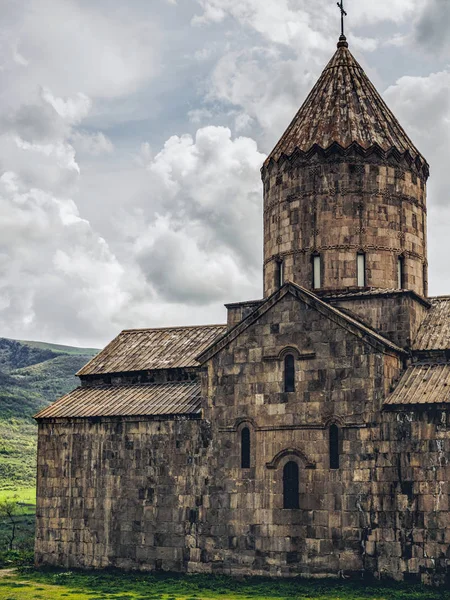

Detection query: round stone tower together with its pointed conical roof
xmin=262 ymin=38 xmax=429 ymax=297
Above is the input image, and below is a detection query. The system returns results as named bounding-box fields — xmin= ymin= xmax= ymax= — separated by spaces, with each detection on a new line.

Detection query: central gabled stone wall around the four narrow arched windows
xmin=200 ymin=296 xmax=401 ymax=576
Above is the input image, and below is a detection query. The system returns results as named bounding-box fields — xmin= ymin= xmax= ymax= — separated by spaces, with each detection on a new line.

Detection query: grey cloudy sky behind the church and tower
xmin=0 ymin=0 xmax=450 ymax=346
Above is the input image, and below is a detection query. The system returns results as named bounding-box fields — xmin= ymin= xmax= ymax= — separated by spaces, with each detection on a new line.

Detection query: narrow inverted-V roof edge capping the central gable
xmin=197 ymin=281 xmax=407 ymax=364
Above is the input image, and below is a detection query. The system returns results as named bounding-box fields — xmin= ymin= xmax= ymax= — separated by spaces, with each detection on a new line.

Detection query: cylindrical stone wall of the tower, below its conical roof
xmin=263 ymin=152 xmax=427 ymax=297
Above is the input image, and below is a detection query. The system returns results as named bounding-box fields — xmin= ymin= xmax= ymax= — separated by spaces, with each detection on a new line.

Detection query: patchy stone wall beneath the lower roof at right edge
xmin=368 ymin=405 xmax=450 ymax=584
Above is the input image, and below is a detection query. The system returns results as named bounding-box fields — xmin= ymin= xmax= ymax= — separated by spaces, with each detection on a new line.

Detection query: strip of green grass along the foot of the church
xmin=0 ymin=569 xmax=450 ymax=600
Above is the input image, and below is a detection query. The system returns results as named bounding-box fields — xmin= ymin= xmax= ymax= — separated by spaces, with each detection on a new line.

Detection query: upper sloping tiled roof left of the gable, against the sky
xmin=77 ymin=325 xmax=227 ymax=375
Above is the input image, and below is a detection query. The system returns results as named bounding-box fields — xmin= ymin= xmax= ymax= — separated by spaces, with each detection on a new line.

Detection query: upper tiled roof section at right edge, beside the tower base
xmin=413 ymin=297 xmax=450 ymax=350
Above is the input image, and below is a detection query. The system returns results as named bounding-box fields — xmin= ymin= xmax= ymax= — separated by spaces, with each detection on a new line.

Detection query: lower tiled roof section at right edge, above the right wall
xmin=385 ymin=363 xmax=450 ymax=404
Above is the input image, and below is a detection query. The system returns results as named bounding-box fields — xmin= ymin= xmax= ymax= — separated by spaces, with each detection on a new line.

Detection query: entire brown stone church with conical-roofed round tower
xmin=36 ymin=36 xmax=450 ymax=583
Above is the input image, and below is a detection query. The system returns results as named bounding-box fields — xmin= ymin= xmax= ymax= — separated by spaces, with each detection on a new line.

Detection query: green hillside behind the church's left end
xmin=0 ymin=338 xmax=98 ymax=490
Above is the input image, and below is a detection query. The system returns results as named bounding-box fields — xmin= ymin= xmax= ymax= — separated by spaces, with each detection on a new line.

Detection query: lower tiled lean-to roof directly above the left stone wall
xmin=35 ymin=382 xmax=201 ymax=419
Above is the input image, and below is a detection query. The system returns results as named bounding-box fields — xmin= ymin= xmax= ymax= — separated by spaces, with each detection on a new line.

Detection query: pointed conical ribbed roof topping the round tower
xmin=266 ymin=38 xmax=427 ymax=172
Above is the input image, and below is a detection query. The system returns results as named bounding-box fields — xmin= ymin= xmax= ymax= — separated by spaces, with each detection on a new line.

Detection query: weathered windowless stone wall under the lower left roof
xmin=36 ymin=419 xmax=210 ymax=571
